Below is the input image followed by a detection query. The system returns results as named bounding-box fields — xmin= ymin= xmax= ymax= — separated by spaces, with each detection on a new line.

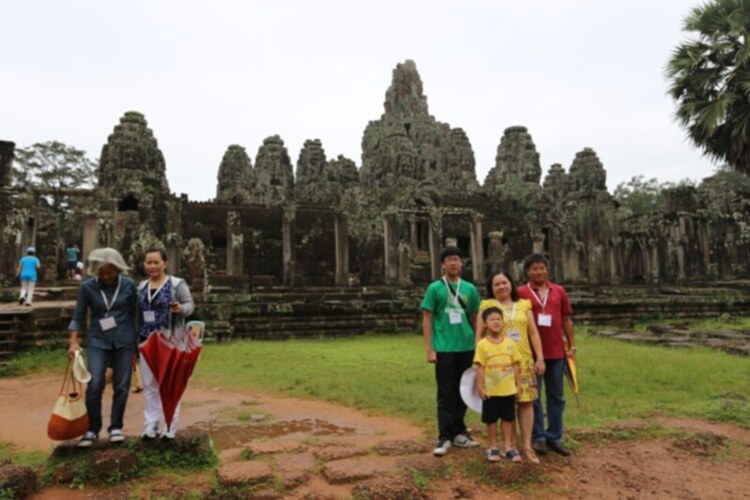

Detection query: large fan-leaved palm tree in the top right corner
xmin=666 ymin=0 xmax=750 ymax=173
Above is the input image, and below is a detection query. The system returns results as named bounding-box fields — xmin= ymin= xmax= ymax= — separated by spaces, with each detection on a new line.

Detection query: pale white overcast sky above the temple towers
xmin=0 ymin=0 xmax=715 ymax=200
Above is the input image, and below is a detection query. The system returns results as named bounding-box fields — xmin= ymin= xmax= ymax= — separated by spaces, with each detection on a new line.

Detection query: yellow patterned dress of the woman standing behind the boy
xmin=479 ymin=299 xmax=539 ymax=403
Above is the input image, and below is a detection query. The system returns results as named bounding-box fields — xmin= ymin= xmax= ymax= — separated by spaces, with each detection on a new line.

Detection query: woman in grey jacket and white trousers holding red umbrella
xmin=138 ymin=248 xmax=195 ymax=440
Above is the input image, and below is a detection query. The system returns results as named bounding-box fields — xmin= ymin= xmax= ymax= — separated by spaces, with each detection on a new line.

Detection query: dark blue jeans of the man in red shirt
xmin=531 ymin=359 xmax=565 ymax=443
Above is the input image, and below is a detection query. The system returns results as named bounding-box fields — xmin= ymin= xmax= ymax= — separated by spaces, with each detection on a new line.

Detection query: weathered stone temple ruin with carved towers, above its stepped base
xmin=0 ymin=60 xmax=750 ymax=293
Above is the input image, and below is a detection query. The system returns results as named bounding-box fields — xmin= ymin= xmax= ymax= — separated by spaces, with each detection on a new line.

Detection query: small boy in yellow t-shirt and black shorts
xmin=474 ymin=307 xmax=521 ymax=462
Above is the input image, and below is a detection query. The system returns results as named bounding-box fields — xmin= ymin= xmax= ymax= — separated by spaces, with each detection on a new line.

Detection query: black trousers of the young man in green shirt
xmin=435 ymin=351 xmax=474 ymax=441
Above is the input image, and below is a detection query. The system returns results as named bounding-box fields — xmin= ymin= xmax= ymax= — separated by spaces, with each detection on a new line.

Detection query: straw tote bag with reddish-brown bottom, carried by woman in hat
xmin=47 ymin=361 xmax=89 ymax=441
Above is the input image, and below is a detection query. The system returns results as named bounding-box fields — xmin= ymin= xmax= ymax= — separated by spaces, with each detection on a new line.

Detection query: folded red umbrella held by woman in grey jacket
xmin=138 ymin=331 xmax=201 ymax=425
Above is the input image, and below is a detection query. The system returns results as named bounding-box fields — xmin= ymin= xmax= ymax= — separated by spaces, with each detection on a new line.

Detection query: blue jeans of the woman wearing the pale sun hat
xmin=86 ymin=344 xmax=136 ymax=434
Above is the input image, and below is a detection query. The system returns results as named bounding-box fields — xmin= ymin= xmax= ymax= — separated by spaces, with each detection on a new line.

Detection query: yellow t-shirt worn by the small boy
xmin=474 ymin=337 xmax=521 ymax=396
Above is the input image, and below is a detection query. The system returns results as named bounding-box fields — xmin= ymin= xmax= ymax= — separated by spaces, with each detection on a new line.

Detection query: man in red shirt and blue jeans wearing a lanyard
xmin=518 ymin=254 xmax=576 ymax=456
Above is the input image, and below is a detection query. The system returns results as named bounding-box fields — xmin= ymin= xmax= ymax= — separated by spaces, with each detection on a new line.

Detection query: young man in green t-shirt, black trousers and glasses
xmin=421 ymin=246 xmax=479 ymax=457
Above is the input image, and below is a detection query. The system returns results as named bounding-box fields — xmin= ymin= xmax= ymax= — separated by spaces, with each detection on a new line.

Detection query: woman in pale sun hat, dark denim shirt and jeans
xmin=68 ymin=248 xmax=138 ymax=447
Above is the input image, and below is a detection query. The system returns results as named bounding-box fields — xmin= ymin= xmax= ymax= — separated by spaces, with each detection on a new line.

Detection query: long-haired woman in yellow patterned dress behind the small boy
xmin=475 ymin=271 xmax=544 ymax=463
